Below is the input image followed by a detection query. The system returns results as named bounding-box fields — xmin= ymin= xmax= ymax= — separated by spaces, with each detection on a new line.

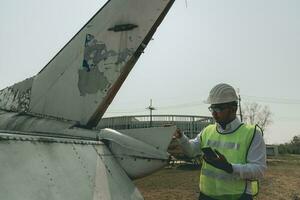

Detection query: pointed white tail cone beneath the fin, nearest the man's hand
xmin=99 ymin=127 xmax=176 ymax=179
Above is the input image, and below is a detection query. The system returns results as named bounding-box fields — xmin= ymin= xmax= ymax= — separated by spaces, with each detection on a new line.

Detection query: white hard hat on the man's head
xmin=205 ymin=83 xmax=238 ymax=104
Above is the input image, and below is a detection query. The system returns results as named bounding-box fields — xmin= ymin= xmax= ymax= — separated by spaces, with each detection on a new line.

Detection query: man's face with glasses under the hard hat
xmin=208 ymin=104 xmax=236 ymax=124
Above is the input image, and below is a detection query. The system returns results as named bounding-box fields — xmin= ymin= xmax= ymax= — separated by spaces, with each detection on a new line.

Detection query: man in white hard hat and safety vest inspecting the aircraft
xmin=175 ymin=83 xmax=267 ymax=200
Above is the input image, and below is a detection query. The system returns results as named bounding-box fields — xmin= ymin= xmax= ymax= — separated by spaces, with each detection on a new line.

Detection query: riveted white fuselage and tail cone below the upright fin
xmin=0 ymin=110 xmax=175 ymax=197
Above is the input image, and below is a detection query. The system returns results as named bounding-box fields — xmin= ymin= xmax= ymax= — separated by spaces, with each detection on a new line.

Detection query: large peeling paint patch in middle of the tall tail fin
xmin=78 ymin=34 xmax=134 ymax=96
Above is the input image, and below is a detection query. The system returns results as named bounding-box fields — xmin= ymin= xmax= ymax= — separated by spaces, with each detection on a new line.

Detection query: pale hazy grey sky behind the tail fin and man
xmin=0 ymin=0 xmax=300 ymax=144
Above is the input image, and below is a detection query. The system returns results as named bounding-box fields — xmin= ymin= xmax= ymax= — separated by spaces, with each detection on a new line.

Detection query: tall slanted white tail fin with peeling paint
xmin=0 ymin=0 xmax=174 ymax=127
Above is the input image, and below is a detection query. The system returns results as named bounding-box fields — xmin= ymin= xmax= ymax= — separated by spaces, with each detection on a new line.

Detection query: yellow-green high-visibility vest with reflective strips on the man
xmin=199 ymin=124 xmax=258 ymax=200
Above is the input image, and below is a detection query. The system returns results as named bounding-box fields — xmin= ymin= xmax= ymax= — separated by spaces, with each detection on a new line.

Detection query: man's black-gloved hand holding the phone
xmin=203 ymin=149 xmax=233 ymax=174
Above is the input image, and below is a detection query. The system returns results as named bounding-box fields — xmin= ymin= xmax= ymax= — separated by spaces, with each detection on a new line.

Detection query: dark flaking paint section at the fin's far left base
xmin=0 ymin=78 xmax=33 ymax=112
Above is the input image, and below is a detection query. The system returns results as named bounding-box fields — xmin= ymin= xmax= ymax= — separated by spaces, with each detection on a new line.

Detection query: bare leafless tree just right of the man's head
xmin=242 ymin=102 xmax=272 ymax=131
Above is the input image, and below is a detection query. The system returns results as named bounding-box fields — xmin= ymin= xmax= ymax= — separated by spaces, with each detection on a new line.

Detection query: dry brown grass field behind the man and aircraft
xmin=135 ymin=155 xmax=300 ymax=200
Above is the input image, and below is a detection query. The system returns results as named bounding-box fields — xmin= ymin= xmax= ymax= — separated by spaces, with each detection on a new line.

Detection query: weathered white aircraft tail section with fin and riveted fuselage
xmin=0 ymin=0 xmax=175 ymax=200
